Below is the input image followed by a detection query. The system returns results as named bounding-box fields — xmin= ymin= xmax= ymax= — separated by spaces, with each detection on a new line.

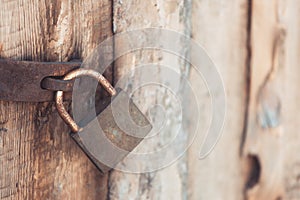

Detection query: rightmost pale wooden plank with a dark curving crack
xmin=244 ymin=0 xmax=300 ymax=199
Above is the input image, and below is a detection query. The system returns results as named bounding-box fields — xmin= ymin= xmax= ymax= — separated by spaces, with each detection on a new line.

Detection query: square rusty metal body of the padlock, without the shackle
xmin=71 ymin=89 xmax=152 ymax=173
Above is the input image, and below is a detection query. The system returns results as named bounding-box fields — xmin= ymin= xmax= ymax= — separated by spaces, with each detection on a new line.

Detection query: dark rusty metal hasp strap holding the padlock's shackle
xmin=0 ymin=59 xmax=81 ymax=102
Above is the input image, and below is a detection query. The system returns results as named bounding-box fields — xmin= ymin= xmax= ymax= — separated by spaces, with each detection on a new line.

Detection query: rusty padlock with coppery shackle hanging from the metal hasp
xmin=56 ymin=69 xmax=152 ymax=173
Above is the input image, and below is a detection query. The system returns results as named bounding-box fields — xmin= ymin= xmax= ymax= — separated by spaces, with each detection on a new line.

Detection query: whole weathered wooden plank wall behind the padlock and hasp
xmin=0 ymin=0 xmax=300 ymax=200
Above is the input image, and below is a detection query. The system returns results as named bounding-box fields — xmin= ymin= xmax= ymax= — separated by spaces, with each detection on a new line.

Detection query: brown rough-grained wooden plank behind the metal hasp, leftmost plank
xmin=0 ymin=0 xmax=112 ymax=199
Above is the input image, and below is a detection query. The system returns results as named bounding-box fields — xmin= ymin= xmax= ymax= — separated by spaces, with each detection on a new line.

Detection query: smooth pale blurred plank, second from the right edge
xmin=188 ymin=0 xmax=249 ymax=199
